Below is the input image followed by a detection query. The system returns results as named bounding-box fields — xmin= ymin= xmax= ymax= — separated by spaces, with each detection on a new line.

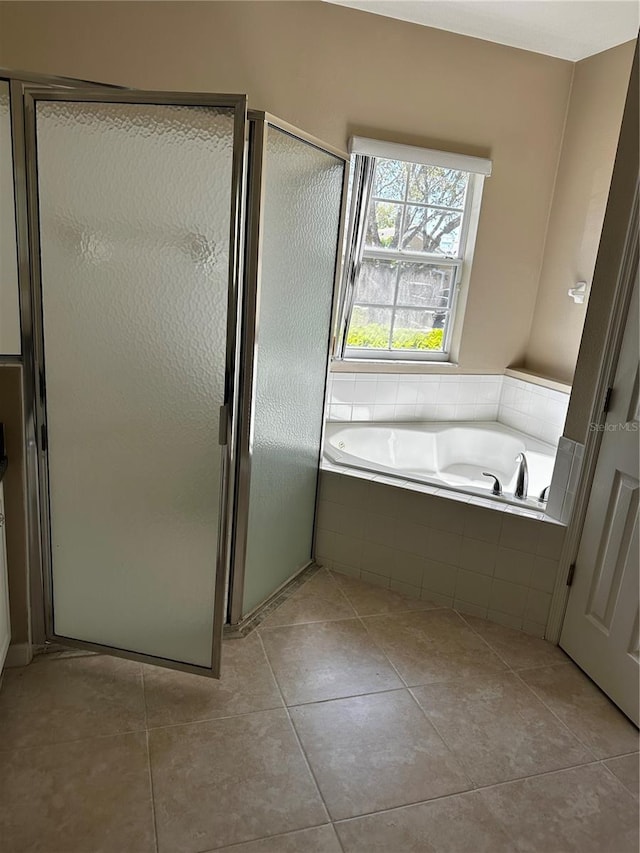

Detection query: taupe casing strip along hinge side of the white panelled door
xmin=546 ymin=177 xmax=640 ymax=644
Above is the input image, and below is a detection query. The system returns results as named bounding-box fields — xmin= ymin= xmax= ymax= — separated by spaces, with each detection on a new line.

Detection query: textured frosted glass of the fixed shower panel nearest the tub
xmin=243 ymin=125 xmax=345 ymax=614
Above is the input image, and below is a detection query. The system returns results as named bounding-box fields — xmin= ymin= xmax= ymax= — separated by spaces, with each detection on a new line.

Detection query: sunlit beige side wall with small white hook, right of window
xmin=524 ymin=42 xmax=634 ymax=382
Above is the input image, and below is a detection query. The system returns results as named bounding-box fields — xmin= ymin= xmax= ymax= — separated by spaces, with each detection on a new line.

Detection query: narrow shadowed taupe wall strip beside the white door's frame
xmin=565 ymin=47 xmax=640 ymax=442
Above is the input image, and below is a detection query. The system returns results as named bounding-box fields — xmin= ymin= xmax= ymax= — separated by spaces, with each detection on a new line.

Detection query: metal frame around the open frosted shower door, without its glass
xmin=21 ymin=83 xmax=247 ymax=678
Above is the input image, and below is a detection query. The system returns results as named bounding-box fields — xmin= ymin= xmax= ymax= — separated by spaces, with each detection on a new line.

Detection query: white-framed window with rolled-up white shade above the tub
xmin=336 ymin=138 xmax=491 ymax=361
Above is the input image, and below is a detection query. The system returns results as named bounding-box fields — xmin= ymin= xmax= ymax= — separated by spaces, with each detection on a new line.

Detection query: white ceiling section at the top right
xmin=327 ymin=0 xmax=640 ymax=62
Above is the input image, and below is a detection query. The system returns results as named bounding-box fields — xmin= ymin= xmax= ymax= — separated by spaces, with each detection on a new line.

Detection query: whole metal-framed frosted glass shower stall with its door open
xmin=0 ymin=73 xmax=347 ymax=676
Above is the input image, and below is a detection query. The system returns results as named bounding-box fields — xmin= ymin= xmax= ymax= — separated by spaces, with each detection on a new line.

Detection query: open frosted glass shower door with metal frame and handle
xmin=26 ymin=91 xmax=246 ymax=674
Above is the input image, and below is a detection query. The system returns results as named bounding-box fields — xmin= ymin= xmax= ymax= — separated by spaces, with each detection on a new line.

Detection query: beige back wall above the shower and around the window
xmin=0 ymin=2 xmax=573 ymax=372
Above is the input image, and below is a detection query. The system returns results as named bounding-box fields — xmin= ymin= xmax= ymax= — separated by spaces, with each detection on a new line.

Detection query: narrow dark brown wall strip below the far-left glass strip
xmin=0 ymin=365 xmax=29 ymax=643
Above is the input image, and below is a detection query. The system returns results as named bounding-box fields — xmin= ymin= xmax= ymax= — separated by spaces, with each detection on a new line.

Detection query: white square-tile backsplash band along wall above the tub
xmin=327 ymin=373 xmax=569 ymax=444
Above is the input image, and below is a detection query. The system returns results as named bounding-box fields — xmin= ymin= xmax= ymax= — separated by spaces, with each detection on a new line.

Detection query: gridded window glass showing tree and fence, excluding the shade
xmin=340 ymin=151 xmax=474 ymax=359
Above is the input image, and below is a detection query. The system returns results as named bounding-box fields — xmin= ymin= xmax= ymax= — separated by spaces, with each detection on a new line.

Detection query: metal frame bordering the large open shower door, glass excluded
xmin=19 ymin=81 xmax=247 ymax=677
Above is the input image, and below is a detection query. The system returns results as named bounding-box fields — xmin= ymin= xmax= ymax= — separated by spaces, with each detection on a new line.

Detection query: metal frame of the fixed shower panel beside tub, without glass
xmin=227 ymin=110 xmax=349 ymax=626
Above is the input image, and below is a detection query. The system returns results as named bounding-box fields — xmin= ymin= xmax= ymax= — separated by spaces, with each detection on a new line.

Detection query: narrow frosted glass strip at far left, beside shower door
xmin=0 ymin=80 xmax=22 ymax=355
